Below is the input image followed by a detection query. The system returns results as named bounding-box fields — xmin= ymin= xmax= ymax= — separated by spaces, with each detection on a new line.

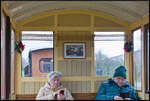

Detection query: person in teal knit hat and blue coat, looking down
xmin=96 ymin=66 xmax=138 ymax=100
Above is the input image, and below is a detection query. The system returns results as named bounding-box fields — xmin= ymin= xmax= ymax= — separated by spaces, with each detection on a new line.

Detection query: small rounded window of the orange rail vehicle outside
xmin=39 ymin=58 xmax=53 ymax=73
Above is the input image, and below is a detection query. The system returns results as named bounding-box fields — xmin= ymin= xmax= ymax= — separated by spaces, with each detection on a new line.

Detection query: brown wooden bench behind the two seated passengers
xmin=16 ymin=93 xmax=96 ymax=100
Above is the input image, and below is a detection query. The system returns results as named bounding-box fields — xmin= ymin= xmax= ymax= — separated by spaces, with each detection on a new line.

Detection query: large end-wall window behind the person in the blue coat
xmin=94 ymin=32 xmax=124 ymax=76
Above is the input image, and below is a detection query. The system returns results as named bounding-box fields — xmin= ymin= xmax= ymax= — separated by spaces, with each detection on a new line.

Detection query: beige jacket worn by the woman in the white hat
xmin=36 ymin=83 xmax=73 ymax=100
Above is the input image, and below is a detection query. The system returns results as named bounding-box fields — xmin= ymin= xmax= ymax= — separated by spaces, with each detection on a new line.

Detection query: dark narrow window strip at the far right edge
xmin=144 ymin=24 xmax=149 ymax=92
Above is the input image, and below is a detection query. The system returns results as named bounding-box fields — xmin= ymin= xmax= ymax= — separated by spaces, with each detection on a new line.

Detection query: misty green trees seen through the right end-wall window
xmin=95 ymin=51 xmax=124 ymax=76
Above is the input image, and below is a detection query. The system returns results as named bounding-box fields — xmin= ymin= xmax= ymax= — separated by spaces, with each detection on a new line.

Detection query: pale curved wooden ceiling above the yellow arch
xmin=3 ymin=1 xmax=149 ymax=24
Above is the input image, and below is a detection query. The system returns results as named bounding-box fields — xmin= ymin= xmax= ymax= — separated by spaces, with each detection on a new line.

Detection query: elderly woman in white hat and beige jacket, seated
xmin=36 ymin=71 xmax=73 ymax=100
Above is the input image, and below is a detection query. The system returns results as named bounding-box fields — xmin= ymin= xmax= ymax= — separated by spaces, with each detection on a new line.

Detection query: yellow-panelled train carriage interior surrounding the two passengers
xmin=1 ymin=0 xmax=149 ymax=100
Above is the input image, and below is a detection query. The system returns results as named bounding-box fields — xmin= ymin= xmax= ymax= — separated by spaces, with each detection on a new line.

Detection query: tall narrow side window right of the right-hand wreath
xmin=133 ymin=29 xmax=142 ymax=90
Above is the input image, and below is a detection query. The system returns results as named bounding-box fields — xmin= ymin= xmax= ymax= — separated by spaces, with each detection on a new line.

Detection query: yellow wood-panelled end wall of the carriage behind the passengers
xmin=16 ymin=10 xmax=148 ymax=99
